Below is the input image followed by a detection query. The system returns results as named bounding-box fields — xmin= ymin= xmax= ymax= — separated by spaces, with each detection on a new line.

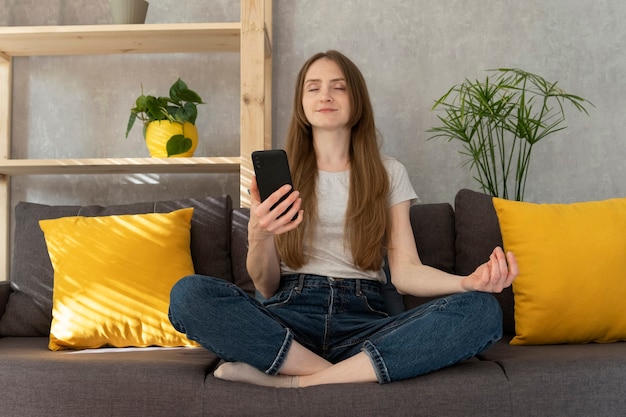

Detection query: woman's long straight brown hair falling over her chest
xmin=276 ymin=50 xmax=389 ymax=270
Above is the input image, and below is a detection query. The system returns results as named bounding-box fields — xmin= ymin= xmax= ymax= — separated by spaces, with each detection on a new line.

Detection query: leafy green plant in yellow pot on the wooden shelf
xmin=126 ymin=78 xmax=203 ymax=158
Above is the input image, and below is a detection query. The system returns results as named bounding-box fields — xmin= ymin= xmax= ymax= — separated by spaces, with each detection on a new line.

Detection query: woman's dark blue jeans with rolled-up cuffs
xmin=169 ymin=274 xmax=502 ymax=383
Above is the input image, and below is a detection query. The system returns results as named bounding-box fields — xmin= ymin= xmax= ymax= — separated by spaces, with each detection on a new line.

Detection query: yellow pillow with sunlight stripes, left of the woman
xmin=39 ymin=208 xmax=195 ymax=350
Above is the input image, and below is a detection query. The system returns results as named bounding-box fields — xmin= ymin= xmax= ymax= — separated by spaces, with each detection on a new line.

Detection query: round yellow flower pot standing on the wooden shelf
xmin=146 ymin=120 xmax=198 ymax=158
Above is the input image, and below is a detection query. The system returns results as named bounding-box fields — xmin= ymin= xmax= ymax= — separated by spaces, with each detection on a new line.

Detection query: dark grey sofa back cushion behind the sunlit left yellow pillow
xmin=0 ymin=196 xmax=232 ymax=336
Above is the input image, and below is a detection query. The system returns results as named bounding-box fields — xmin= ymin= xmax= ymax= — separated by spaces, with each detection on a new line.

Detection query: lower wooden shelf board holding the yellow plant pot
xmin=0 ymin=156 xmax=240 ymax=175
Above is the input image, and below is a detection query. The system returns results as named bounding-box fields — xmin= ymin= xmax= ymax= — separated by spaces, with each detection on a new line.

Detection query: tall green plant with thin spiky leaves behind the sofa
xmin=428 ymin=68 xmax=593 ymax=201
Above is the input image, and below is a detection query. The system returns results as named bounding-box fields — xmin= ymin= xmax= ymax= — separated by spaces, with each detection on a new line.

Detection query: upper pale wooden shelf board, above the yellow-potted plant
xmin=0 ymin=22 xmax=241 ymax=59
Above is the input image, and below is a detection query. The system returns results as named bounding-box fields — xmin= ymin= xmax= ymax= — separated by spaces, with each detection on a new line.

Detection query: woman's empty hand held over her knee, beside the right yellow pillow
xmin=461 ymin=247 xmax=519 ymax=293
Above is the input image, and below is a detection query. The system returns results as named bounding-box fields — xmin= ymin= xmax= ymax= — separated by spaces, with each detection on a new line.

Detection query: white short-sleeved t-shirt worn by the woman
xmin=281 ymin=156 xmax=417 ymax=282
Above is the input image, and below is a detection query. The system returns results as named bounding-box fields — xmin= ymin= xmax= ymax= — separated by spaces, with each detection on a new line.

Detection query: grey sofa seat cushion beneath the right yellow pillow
xmin=479 ymin=336 xmax=626 ymax=417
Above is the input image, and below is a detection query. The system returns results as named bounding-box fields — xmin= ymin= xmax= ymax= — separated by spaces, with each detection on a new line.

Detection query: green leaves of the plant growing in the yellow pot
xmin=126 ymin=78 xmax=203 ymax=155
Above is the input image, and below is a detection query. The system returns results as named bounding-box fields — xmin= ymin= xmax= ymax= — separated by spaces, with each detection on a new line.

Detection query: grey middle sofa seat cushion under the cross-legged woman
xmin=203 ymin=359 xmax=511 ymax=417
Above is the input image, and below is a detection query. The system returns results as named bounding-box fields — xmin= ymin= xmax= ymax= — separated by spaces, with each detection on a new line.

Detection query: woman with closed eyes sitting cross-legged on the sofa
xmin=170 ymin=51 xmax=518 ymax=387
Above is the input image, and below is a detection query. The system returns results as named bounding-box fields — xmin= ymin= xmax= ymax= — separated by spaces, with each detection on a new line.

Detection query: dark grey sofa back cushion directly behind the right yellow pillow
xmin=454 ymin=189 xmax=515 ymax=335
